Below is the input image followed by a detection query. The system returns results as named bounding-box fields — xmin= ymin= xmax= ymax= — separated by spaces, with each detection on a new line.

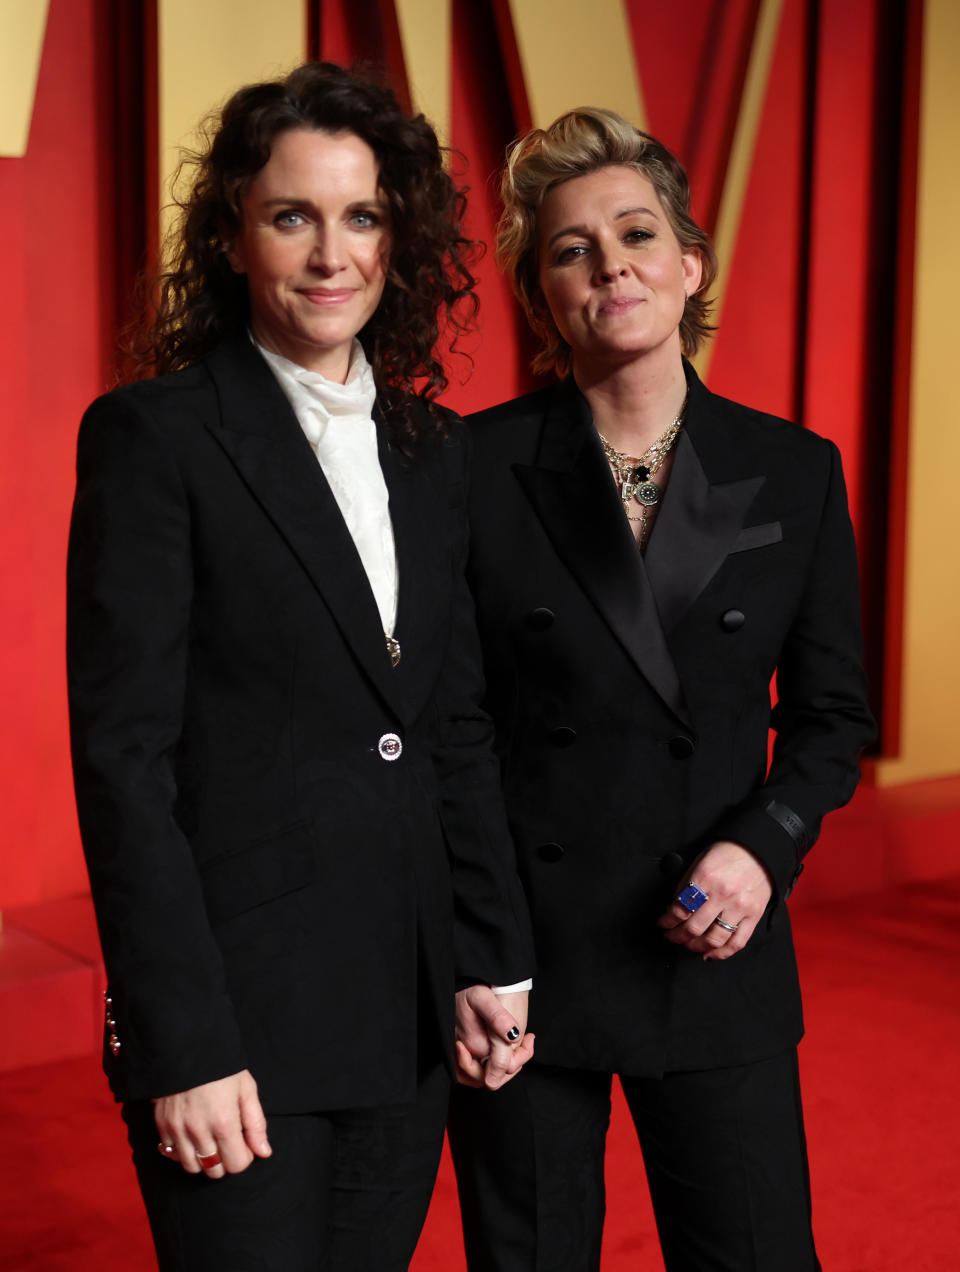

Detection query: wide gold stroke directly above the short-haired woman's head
xmin=510 ymin=0 xmax=647 ymax=131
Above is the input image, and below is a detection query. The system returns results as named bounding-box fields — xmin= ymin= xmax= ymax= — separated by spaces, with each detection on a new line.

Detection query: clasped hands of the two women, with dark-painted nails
xmin=456 ymin=985 xmax=534 ymax=1091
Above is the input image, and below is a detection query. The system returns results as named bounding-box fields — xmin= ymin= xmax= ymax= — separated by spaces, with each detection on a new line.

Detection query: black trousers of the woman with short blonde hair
xmin=449 ymin=1049 xmax=820 ymax=1272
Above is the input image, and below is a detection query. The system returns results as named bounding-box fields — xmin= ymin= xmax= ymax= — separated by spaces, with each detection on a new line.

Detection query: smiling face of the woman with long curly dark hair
xmin=226 ymin=128 xmax=390 ymax=383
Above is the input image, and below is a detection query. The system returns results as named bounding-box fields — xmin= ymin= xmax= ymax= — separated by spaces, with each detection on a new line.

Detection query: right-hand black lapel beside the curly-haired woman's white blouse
xmin=378 ymin=420 xmax=450 ymax=716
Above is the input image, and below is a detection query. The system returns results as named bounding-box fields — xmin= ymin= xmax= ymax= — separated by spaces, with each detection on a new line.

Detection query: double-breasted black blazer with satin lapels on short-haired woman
xmin=468 ymin=368 xmax=874 ymax=1075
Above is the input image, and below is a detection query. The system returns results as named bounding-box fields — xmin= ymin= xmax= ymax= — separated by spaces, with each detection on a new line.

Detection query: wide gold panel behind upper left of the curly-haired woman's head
xmin=156 ymin=0 xmax=306 ymax=223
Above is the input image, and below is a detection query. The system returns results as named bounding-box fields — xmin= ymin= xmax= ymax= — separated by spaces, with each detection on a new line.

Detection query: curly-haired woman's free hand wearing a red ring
xmin=154 ymin=1068 xmax=273 ymax=1179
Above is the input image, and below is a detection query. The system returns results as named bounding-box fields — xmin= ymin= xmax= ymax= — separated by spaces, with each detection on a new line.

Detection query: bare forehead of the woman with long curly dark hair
xmin=250 ymin=128 xmax=379 ymax=198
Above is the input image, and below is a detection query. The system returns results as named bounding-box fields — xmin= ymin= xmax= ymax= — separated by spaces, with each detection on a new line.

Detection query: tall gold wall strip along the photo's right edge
xmin=876 ymin=0 xmax=960 ymax=786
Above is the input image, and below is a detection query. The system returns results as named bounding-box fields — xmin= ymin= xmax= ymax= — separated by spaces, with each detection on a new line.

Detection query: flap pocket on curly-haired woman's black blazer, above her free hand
xmin=200 ymin=823 xmax=315 ymax=922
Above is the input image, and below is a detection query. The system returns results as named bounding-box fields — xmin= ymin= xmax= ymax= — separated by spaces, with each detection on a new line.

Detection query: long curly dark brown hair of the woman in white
xmin=131 ymin=62 xmax=478 ymax=441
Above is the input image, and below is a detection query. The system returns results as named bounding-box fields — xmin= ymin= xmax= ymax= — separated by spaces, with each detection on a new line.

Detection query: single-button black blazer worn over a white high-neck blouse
xmin=67 ymin=337 xmax=531 ymax=1112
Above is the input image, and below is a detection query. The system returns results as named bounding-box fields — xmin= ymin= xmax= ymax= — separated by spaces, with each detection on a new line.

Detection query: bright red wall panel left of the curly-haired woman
xmin=0 ymin=0 xmax=122 ymax=906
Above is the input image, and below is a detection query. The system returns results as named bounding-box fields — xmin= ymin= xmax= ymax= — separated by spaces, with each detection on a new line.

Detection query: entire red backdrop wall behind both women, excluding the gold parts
xmin=0 ymin=0 xmax=913 ymax=906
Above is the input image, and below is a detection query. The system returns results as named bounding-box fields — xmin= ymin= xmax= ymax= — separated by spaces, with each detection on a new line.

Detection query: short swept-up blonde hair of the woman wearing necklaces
xmin=496 ymin=106 xmax=717 ymax=375
